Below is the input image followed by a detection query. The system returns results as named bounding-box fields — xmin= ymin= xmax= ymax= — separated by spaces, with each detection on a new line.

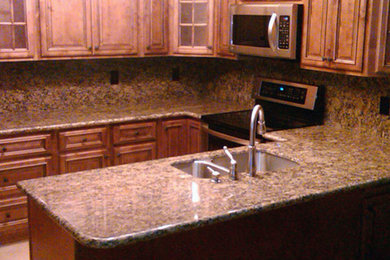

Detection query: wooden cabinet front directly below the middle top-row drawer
xmin=60 ymin=150 xmax=109 ymax=173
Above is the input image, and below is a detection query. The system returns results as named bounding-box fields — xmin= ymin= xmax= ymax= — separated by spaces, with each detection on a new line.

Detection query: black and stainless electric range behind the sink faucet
xmin=202 ymin=79 xmax=324 ymax=151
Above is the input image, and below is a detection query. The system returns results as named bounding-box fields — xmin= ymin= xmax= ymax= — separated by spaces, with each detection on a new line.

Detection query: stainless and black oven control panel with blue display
xmin=254 ymin=79 xmax=318 ymax=110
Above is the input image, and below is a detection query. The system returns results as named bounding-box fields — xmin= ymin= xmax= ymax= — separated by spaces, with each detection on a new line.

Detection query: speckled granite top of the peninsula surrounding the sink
xmin=19 ymin=126 xmax=390 ymax=247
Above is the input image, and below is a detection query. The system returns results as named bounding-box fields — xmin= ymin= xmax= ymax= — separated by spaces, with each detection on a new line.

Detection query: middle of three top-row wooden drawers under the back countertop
xmin=59 ymin=127 xmax=107 ymax=151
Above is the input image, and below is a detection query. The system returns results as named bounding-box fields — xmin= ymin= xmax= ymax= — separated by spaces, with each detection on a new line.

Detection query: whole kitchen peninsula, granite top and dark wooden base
xmin=18 ymin=121 xmax=390 ymax=259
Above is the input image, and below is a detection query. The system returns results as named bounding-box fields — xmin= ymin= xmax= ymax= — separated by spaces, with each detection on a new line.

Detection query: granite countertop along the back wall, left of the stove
xmin=0 ymin=97 xmax=252 ymax=135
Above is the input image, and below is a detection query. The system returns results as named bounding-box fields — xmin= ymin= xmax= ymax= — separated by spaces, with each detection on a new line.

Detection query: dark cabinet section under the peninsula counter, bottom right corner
xmin=362 ymin=186 xmax=390 ymax=259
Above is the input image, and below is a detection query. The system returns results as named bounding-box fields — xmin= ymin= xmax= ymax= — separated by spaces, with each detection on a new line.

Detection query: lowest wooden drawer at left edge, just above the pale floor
xmin=0 ymin=198 xmax=27 ymax=223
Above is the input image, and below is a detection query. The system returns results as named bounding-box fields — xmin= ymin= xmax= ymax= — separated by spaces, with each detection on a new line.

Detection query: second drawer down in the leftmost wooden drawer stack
xmin=0 ymin=157 xmax=51 ymax=189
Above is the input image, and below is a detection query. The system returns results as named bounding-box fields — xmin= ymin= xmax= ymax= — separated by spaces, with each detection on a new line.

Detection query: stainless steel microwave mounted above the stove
xmin=229 ymin=3 xmax=298 ymax=59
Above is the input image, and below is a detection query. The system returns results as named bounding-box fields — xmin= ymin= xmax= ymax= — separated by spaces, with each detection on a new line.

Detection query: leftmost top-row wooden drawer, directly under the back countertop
xmin=0 ymin=134 xmax=52 ymax=159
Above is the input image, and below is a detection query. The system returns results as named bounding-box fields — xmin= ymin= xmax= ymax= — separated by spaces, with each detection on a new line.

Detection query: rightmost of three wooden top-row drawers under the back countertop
xmin=113 ymin=122 xmax=156 ymax=144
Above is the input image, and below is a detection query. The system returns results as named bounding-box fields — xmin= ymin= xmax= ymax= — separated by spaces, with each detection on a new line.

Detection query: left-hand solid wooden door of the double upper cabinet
xmin=39 ymin=0 xmax=92 ymax=57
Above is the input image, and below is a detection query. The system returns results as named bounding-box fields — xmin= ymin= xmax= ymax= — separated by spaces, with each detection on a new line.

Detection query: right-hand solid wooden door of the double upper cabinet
xmin=93 ymin=0 xmax=139 ymax=55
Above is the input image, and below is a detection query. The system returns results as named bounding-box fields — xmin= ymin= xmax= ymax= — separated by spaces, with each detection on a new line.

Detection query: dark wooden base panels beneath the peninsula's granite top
xmin=28 ymin=190 xmax=368 ymax=260
